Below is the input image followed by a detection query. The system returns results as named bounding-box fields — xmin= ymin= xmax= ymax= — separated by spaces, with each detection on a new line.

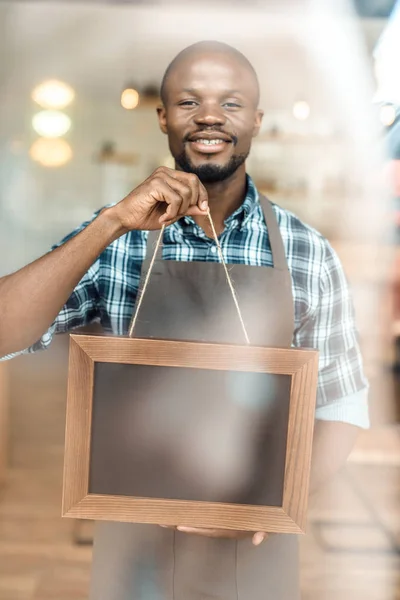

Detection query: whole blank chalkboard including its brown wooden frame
xmin=63 ymin=335 xmax=318 ymax=533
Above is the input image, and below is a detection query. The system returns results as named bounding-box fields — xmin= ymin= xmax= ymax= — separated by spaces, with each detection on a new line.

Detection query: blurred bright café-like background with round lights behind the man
xmin=0 ymin=0 xmax=400 ymax=600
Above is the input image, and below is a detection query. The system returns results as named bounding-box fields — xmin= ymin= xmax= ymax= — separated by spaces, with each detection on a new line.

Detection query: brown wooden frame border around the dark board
xmin=62 ymin=335 xmax=318 ymax=533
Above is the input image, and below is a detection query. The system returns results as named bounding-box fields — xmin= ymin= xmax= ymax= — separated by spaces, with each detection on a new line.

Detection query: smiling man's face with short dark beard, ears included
xmin=158 ymin=53 xmax=262 ymax=183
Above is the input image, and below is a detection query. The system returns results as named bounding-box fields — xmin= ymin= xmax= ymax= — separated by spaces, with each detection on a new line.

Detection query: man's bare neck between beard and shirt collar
xmin=194 ymin=165 xmax=246 ymax=237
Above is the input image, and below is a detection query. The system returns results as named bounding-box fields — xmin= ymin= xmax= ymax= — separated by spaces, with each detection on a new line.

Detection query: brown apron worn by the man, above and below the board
xmin=90 ymin=197 xmax=299 ymax=600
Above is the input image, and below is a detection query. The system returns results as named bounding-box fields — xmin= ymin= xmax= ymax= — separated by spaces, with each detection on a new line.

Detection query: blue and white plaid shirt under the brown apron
xmin=5 ymin=177 xmax=369 ymax=427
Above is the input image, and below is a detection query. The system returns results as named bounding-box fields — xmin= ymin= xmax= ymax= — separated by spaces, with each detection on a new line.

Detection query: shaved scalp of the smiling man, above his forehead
xmin=160 ymin=41 xmax=260 ymax=106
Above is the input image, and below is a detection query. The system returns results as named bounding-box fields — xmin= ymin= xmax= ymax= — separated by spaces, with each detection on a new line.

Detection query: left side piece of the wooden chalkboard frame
xmin=62 ymin=339 xmax=94 ymax=514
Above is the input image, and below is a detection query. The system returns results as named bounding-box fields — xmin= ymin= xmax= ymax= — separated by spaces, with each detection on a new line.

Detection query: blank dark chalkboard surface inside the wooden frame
xmin=88 ymin=363 xmax=292 ymax=506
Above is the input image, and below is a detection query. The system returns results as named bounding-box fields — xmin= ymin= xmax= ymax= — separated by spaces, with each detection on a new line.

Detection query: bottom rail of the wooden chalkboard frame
xmin=64 ymin=494 xmax=303 ymax=533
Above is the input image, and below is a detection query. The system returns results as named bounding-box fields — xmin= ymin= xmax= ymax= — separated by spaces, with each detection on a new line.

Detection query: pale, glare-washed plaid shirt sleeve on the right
xmin=295 ymin=242 xmax=369 ymax=428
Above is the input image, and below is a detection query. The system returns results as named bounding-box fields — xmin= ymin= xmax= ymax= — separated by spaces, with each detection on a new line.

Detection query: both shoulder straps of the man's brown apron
xmin=145 ymin=194 xmax=288 ymax=271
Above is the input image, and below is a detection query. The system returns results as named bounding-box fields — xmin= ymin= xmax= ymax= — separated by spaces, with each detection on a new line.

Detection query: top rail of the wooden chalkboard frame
xmin=71 ymin=335 xmax=315 ymax=375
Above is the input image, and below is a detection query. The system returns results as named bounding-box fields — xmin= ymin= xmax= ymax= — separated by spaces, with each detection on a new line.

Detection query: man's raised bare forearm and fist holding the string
xmin=0 ymin=167 xmax=208 ymax=357
